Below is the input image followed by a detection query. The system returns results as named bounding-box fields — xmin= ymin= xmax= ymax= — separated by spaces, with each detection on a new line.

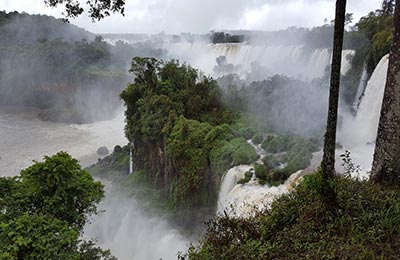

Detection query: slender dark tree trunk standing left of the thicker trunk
xmin=321 ymin=0 xmax=346 ymax=197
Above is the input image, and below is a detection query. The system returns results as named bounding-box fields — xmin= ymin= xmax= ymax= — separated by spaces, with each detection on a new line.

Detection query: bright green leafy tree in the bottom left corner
xmin=0 ymin=152 xmax=115 ymax=260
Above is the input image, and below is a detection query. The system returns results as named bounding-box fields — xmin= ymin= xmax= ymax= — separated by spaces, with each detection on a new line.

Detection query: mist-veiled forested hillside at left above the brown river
xmin=0 ymin=12 xmax=163 ymax=123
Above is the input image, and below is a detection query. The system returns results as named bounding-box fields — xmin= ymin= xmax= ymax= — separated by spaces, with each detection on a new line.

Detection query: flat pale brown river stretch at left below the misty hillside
xmin=0 ymin=107 xmax=128 ymax=176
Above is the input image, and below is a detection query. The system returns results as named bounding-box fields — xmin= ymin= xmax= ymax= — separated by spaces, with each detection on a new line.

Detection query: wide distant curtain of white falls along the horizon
xmin=163 ymin=42 xmax=354 ymax=80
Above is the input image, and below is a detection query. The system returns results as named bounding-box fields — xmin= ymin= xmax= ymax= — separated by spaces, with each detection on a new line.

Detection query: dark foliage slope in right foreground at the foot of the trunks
xmin=181 ymin=173 xmax=400 ymax=259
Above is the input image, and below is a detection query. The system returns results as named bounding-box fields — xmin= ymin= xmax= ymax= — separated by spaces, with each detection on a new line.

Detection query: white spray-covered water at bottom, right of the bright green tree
xmin=85 ymin=191 xmax=187 ymax=260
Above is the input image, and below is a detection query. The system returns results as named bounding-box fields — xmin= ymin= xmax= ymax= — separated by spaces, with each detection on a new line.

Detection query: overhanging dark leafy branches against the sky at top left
xmin=44 ymin=0 xmax=125 ymax=21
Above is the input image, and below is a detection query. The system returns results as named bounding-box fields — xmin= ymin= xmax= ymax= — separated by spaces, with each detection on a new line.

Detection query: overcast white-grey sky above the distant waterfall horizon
xmin=0 ymin=0 xmax=382 ymax=34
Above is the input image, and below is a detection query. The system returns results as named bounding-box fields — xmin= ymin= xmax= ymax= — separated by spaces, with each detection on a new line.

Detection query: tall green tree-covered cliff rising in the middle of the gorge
xmin=121 ymin=58 xmax=232 ymax=211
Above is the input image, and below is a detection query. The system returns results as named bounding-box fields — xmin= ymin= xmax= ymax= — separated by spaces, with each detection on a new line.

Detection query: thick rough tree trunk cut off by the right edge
xmin=371 ymin=0 xmax=400 ymax=184
